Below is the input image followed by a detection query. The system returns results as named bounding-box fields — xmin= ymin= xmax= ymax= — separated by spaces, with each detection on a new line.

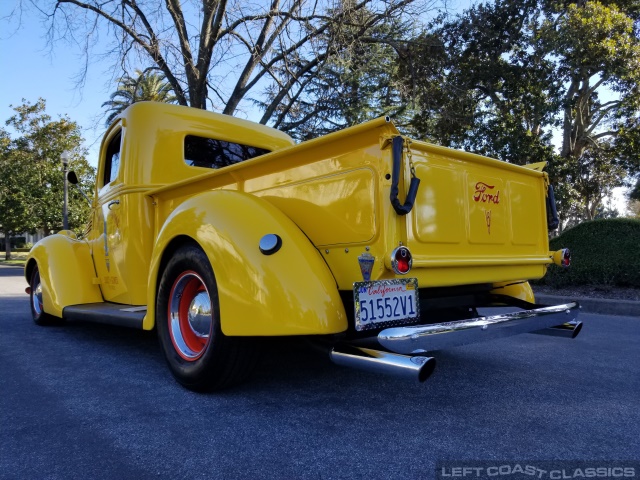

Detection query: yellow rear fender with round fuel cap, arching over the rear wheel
xmin=144 ymin=190 xmax=347 ymax=336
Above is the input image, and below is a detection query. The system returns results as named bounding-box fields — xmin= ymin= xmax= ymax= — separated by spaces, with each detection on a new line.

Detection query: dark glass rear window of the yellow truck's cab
xmin=184 ymin=135 xmax=269 ymax=168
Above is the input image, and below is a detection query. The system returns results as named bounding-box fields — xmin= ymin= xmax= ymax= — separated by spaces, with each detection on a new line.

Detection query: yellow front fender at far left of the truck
xmin=25 ymin=234 xmax=103 ymax=317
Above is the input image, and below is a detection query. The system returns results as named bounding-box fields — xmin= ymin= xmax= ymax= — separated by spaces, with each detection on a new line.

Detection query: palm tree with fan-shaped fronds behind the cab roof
xmin=102 ymin=69 xmax=176 ymax=126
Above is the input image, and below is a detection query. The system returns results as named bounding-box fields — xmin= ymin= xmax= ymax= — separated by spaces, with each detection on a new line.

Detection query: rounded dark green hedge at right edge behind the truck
xmin=536 ymin=218 xmax=640 ymax=288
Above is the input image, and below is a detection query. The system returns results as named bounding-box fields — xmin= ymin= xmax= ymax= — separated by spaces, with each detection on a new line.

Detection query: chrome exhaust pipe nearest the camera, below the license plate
xmin=329 ymin=345 xmax=436 ymax=382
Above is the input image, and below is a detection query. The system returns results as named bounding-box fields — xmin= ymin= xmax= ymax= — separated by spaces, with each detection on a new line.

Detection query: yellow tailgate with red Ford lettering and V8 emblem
xmin=404 ymin=142 xmax=550 ymax=285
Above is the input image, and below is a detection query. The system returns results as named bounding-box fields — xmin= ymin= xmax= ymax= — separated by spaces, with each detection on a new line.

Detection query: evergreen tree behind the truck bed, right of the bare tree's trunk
xmin=268 ymin=2 xmax=411 ymax=140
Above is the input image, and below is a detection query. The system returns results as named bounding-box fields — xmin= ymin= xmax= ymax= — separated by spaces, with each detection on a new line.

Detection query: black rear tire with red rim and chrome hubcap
xmin=156 ymin=244 xmax=258 ymax=392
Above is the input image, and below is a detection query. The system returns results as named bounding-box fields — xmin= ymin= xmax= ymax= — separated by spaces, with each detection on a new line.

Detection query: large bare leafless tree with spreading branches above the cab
xmin=36 ymin=0 xmax=436 ymax=124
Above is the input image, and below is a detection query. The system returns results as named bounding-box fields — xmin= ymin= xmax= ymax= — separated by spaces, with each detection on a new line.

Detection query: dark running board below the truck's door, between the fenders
xmin=62 ymin=302 xmax=147 ymax=329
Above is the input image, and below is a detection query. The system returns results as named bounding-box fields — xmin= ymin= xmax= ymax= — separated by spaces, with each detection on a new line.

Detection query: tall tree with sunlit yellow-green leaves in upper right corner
xmin=538 ymin=1 xmax=640 ymax=158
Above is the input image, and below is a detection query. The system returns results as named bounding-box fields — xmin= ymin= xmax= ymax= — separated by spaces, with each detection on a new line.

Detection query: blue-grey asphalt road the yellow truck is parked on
xmin=0 ymin=267 xmax=640 ymax=479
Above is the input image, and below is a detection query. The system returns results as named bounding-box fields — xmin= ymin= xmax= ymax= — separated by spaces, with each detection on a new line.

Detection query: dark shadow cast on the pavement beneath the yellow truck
xmin=33 ymin=321 xmax=552 ymax=401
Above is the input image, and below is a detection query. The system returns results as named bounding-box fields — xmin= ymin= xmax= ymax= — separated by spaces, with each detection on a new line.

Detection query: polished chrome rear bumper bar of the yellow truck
xmin=378 ymin=302 xmax=582 ymax=354
